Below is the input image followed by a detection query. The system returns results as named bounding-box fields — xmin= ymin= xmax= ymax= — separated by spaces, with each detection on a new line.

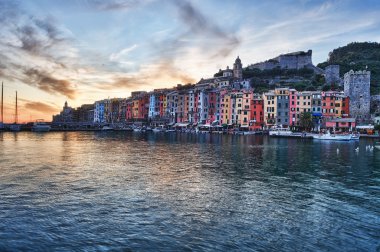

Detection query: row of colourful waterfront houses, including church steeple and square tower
xmin=53 ymin=58 xmax=371 ymax=130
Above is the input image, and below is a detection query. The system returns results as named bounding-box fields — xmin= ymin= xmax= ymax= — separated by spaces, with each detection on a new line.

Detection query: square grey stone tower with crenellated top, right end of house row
xmin=344 ymin=70 xmax=371 ymax=122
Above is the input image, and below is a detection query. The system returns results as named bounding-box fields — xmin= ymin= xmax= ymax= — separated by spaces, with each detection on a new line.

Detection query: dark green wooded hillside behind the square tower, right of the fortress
xmin=317 ymin=42 xmax=380 ymax=94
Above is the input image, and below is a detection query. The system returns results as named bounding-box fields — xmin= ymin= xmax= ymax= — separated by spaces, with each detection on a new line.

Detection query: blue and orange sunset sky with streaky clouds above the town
xmin=0 ymin=0 xmax=380 ymax=122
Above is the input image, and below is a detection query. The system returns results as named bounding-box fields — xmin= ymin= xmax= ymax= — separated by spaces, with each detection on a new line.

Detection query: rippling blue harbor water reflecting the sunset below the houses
xmin=0 ymin=132 xmax=380 ymax=251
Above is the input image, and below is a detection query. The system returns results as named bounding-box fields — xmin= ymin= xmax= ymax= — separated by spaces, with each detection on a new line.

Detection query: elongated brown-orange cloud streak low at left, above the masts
xmin=24 ymin=69 xmax=76 ymax=99
